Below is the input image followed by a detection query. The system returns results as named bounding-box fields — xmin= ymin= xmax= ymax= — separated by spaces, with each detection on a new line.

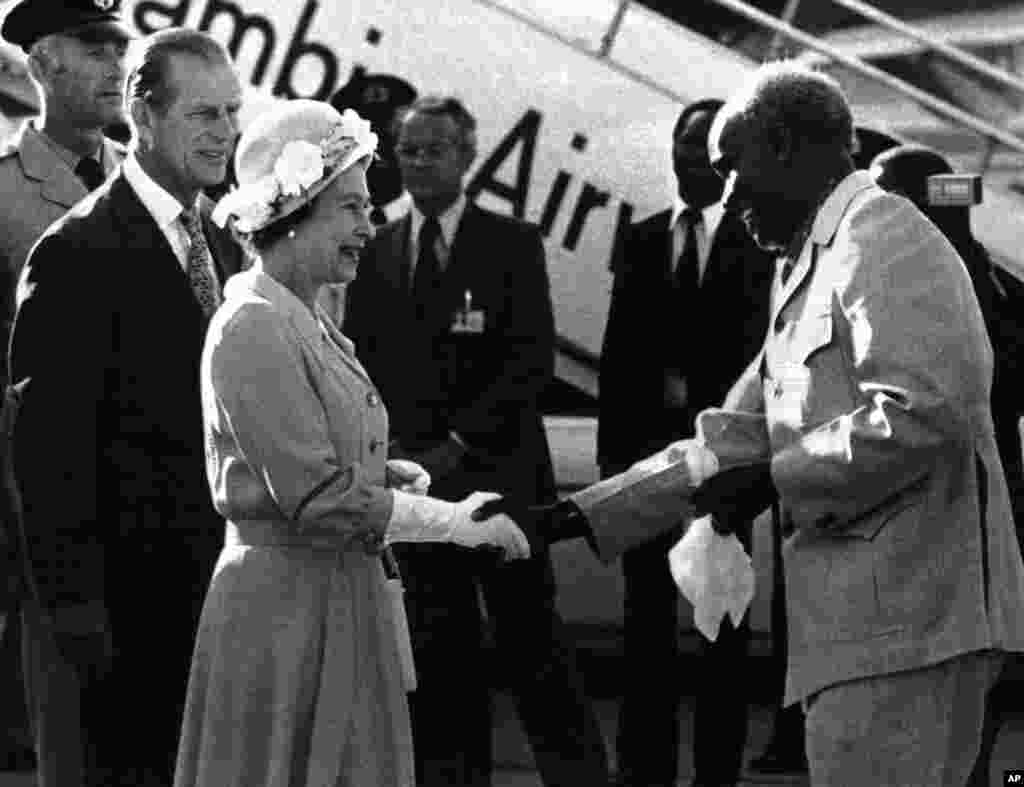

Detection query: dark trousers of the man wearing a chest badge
xmin=395 ymin=544 xmax=608 ymax=787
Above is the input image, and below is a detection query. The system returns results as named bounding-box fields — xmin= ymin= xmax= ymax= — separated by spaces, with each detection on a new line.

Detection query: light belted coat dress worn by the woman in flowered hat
xmin=174 ymin=268 xmax=414 ymax=787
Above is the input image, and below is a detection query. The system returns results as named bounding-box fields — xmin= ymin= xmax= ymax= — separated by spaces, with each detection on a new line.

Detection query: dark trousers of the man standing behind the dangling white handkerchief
xmin=616 ymin=521 xmax=751 ymax=787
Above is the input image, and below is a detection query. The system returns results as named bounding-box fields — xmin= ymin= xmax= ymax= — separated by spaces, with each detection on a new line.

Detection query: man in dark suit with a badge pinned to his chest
xmin=344 ymin=97 xmax=607 ymax=787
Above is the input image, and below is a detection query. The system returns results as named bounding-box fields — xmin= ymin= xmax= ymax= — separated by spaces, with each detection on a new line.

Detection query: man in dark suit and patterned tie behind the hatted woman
xmin=11 ymin=29 xmax=242 ymax=787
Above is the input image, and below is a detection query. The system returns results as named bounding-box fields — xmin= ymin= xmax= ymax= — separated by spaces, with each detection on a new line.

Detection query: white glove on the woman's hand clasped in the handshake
xmin=385 ymin=489 xmax=529 ymax=560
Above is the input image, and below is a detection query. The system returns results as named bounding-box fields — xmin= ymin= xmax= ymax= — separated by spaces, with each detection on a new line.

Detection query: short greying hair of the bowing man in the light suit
xmin=722 ymin=60 xmax=856 ymax=154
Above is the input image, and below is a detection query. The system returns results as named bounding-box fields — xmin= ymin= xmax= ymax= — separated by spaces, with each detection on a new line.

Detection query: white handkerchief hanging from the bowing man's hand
xmin=669 ymin=516 xmax=754 ymax=642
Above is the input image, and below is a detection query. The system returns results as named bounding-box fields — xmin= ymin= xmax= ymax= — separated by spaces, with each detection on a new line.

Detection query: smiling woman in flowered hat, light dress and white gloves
xmin=174 ymin=100 xmax=529 ymax=787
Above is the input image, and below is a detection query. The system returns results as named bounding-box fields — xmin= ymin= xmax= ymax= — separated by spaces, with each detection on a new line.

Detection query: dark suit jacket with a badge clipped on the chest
xmin=344 ymin=204 xmax=554 ymax=500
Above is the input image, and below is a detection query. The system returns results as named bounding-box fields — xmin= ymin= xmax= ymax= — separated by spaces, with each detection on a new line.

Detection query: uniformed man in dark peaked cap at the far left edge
xmin=0 ymin=0 xmax=130 ymax=768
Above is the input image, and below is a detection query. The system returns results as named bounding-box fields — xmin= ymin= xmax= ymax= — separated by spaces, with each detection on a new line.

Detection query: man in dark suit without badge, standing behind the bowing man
xmin=598 ymin=99 xmax=774 ymax=787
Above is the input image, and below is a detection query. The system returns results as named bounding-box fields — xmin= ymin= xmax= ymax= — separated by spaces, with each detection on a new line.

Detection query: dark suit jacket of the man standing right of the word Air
xmin=597 ymin=205 xmax=774 ymax=474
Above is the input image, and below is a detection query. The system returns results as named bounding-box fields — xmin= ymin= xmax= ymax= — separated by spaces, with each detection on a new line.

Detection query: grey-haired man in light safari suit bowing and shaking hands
xmin=479 ymin=62 xmax=1024 ymax=787
